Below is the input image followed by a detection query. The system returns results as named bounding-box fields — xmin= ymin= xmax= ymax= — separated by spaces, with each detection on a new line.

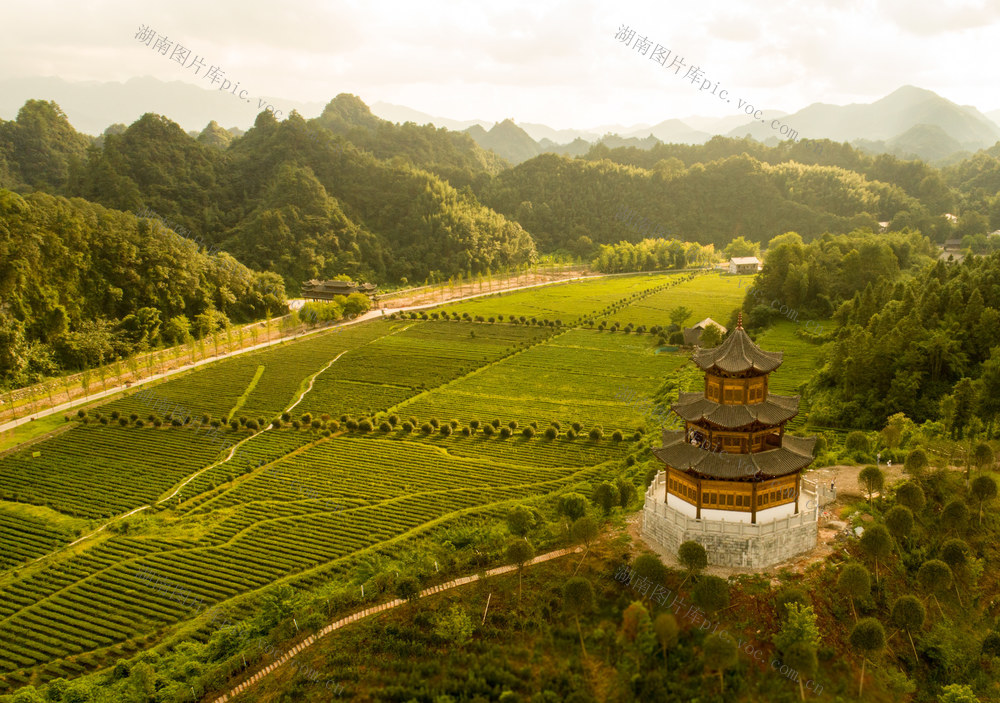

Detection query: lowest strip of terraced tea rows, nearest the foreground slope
xmin=0 ymin=477 xmax=592 ymax=676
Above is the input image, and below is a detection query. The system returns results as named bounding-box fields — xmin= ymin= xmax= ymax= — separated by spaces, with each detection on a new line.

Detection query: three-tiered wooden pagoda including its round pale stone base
xmin=644 ymin=315 xmax=818 ymax=566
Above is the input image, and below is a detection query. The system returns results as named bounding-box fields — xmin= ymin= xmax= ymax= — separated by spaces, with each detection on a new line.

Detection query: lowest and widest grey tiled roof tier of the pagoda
xmin=653 ymin=430 xmax=816 ymax=479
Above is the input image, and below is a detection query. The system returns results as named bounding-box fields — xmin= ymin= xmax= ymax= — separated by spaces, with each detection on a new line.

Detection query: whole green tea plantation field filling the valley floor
xmin=0 ymin=274 xmax=818 ymax=693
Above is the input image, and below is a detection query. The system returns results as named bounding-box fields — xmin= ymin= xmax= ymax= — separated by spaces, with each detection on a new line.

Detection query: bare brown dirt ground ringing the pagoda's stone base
xmin=626 ymin=464 xmax=904 ymax=583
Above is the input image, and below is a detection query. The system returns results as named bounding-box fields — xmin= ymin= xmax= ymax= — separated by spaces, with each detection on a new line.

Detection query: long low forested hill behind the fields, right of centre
xmin=480 ymin=154 xmax=920 ymax=251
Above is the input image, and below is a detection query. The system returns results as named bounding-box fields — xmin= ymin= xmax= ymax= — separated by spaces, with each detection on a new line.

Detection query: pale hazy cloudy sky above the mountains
xmin=0 ymin=0 xmax=1000 ymax=128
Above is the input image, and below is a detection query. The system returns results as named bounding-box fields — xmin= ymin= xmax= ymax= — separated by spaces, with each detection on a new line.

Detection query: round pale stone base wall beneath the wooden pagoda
xmin=642 ymin=472 xmax=819 ymax=569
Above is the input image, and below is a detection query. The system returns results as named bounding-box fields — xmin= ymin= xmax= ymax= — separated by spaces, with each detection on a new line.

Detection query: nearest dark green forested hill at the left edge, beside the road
xmin=0 ymin=189 xmax=285 ymax=385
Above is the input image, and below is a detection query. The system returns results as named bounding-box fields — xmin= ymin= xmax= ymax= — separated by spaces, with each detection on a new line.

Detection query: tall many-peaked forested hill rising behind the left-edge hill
xmin=0 ymin=101 xmax=535 ymax=292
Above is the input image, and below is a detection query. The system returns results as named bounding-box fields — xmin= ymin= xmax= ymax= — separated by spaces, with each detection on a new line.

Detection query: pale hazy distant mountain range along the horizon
xmin=0 ymin=77 xmax=1000 ymax=165
